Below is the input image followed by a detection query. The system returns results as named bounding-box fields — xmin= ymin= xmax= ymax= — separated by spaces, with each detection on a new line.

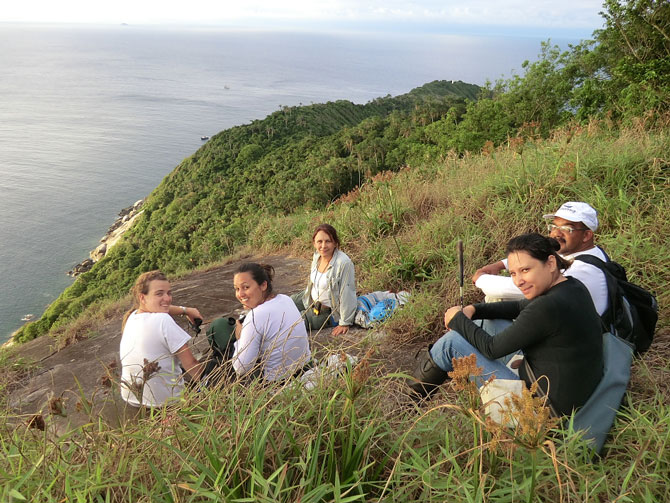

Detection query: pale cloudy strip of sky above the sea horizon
xmin=0 ymin=0 xmax=603 ymax=37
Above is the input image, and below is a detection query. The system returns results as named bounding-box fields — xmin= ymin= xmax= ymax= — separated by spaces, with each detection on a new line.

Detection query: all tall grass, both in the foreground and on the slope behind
xmin=0 ymin=122 xmax=670 ymax=502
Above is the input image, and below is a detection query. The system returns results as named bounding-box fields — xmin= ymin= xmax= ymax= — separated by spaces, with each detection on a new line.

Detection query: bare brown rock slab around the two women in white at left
xmin=9 ymin=255 xmax=322 ymax=435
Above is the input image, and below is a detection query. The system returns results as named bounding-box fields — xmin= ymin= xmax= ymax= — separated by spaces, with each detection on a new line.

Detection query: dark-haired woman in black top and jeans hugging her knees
xmin=411 ymin=234 xmax=603 ymax=420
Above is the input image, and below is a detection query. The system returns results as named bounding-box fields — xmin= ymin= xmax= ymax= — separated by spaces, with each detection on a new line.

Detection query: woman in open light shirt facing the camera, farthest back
xmin=291 ymin=224 xmax=356 ymax=335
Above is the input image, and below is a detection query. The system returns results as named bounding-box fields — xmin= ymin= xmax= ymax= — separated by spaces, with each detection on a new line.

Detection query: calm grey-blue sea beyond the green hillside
xmin=0 ymin=24 xmax=576 ymax=342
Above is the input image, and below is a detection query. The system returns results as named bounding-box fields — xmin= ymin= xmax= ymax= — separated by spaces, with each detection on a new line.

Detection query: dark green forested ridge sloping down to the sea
xmin=15 ymin=81 xmax=481 ymax=340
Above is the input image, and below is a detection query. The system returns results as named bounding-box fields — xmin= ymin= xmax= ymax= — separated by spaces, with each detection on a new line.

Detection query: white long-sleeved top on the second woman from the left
xmin=233 ymin=294 xmax=312 ymax=381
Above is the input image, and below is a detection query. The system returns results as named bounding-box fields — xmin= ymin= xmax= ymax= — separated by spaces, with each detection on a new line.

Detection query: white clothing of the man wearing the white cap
xmin=475 ymin=246 xmax=608 ymax=316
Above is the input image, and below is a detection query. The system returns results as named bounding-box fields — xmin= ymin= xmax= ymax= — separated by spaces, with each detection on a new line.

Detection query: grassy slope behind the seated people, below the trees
xmin=255 ymin=121 xmax=670 ymax=336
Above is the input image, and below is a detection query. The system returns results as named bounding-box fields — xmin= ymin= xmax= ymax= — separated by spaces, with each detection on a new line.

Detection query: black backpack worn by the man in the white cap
xmin=575 ymin=255 xmax=658 ymax=354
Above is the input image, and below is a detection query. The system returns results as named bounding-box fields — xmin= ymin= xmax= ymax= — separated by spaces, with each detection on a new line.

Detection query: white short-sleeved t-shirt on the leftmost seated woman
xmin=120 ymin=311 xmax=191 ymax=407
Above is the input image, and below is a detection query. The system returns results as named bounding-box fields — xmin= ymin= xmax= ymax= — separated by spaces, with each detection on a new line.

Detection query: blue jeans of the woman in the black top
xmin=430 ymin=320 xmax=519 ymax=386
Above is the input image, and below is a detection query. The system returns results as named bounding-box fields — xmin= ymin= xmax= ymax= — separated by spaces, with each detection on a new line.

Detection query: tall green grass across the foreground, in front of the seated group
xmin=0 ymin=352 xmax=670 ymax=502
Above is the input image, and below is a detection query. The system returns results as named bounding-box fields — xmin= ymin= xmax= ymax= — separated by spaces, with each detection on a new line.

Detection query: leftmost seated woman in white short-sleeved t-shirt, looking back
xmin=120 ymin=271 xmax=202 ymax=407
